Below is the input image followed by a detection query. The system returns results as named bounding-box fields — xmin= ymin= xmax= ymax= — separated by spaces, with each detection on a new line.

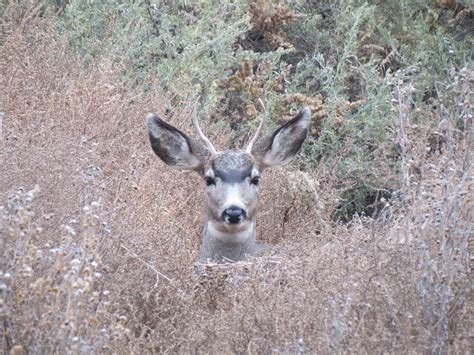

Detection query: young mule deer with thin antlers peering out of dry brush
xmin=147 ymin=104 xmax=311 ymax=262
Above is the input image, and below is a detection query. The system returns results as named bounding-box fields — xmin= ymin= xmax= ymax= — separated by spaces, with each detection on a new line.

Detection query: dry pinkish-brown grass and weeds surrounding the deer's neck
xmin=0 ymin=6 xmax=474 ymax=353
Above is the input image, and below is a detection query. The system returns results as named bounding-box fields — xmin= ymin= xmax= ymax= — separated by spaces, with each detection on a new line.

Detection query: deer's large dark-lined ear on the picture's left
xmin=146 ymin=113 xmax=210 ymax=171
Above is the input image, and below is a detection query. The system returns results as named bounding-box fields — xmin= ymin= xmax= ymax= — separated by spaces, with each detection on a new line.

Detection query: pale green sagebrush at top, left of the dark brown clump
xmin=61 ymin=1 xmax=262 ymax=102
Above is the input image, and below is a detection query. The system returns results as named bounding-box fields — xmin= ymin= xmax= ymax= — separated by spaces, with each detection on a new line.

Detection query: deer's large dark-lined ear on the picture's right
xmin=252 ymin=107 xmax=311 ymax=170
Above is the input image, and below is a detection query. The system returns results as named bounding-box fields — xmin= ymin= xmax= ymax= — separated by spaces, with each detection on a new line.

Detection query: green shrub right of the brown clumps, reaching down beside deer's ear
xmin=282 ymin=1 xmax=470 ymax=220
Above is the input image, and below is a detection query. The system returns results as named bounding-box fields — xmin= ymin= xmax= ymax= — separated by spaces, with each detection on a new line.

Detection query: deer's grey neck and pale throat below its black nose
xmin=199 ymin=209 xmax=258 ymax=262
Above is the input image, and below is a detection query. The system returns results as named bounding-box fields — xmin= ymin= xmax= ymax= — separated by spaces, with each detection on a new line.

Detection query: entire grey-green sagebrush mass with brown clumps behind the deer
xmin=55 ymin=0 xmax=469 ymax=220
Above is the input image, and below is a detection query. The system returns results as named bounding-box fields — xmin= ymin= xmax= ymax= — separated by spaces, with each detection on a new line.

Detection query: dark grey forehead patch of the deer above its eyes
xmin=207 ymin=150 xmax=258 ymax=183
